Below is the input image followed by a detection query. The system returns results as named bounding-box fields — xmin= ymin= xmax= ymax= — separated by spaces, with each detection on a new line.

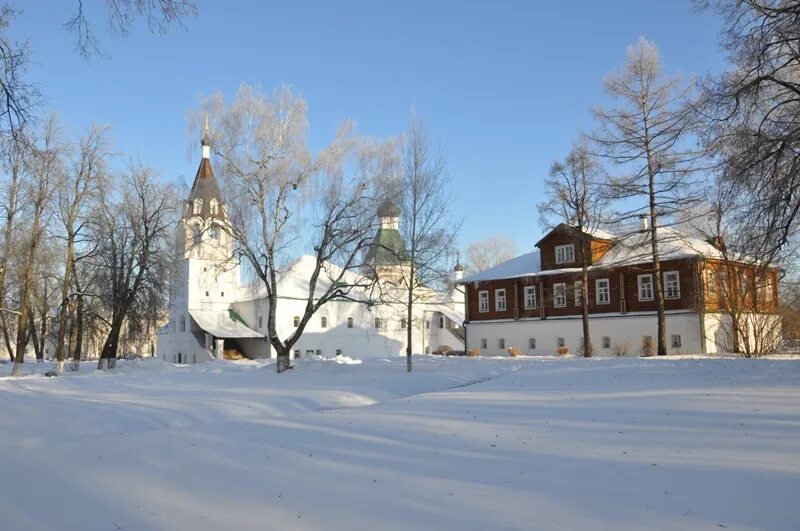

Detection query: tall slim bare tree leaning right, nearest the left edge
xmin=11 ymin=116 xmax=63 ymax=376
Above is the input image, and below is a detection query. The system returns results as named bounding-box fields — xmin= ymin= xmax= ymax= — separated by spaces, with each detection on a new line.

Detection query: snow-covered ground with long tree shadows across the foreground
xmin=0 ymin=357 xmax=800 ymax=531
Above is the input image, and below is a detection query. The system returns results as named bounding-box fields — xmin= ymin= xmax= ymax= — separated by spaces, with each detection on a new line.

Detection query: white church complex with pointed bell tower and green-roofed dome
xmin=156 ymin=134 xmax=464 ymax=363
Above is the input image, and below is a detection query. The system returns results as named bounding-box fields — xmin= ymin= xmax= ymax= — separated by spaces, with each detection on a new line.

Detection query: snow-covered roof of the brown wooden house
xmin=460 ymin=227 xmax=722 ymax=284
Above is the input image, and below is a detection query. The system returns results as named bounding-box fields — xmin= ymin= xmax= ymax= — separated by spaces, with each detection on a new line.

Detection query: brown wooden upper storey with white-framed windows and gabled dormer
xmin=464 ymin=223 xmax=778 ymax=321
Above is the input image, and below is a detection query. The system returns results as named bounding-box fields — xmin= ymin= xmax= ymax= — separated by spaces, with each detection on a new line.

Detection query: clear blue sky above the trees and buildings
xmin=12 ymin=0 xmax=724 ymax=251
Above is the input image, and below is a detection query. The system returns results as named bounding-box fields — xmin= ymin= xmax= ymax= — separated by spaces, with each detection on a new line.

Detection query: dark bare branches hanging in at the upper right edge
xmin=697 ymin=0 xmax=800 ymax=261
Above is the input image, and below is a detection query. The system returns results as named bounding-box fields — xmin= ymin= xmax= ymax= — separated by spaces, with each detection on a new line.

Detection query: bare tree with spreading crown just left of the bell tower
xmin=92 ymin=163 xmax=178 ymax=369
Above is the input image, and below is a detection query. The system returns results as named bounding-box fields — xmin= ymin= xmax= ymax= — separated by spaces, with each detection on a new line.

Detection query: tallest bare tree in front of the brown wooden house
xmin=594 ymin=38 xmax=702 ymax=356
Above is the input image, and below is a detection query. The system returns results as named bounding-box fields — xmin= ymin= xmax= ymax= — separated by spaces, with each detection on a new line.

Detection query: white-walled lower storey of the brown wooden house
xmin=465 ymin=311 xmax=760 ymax=356
